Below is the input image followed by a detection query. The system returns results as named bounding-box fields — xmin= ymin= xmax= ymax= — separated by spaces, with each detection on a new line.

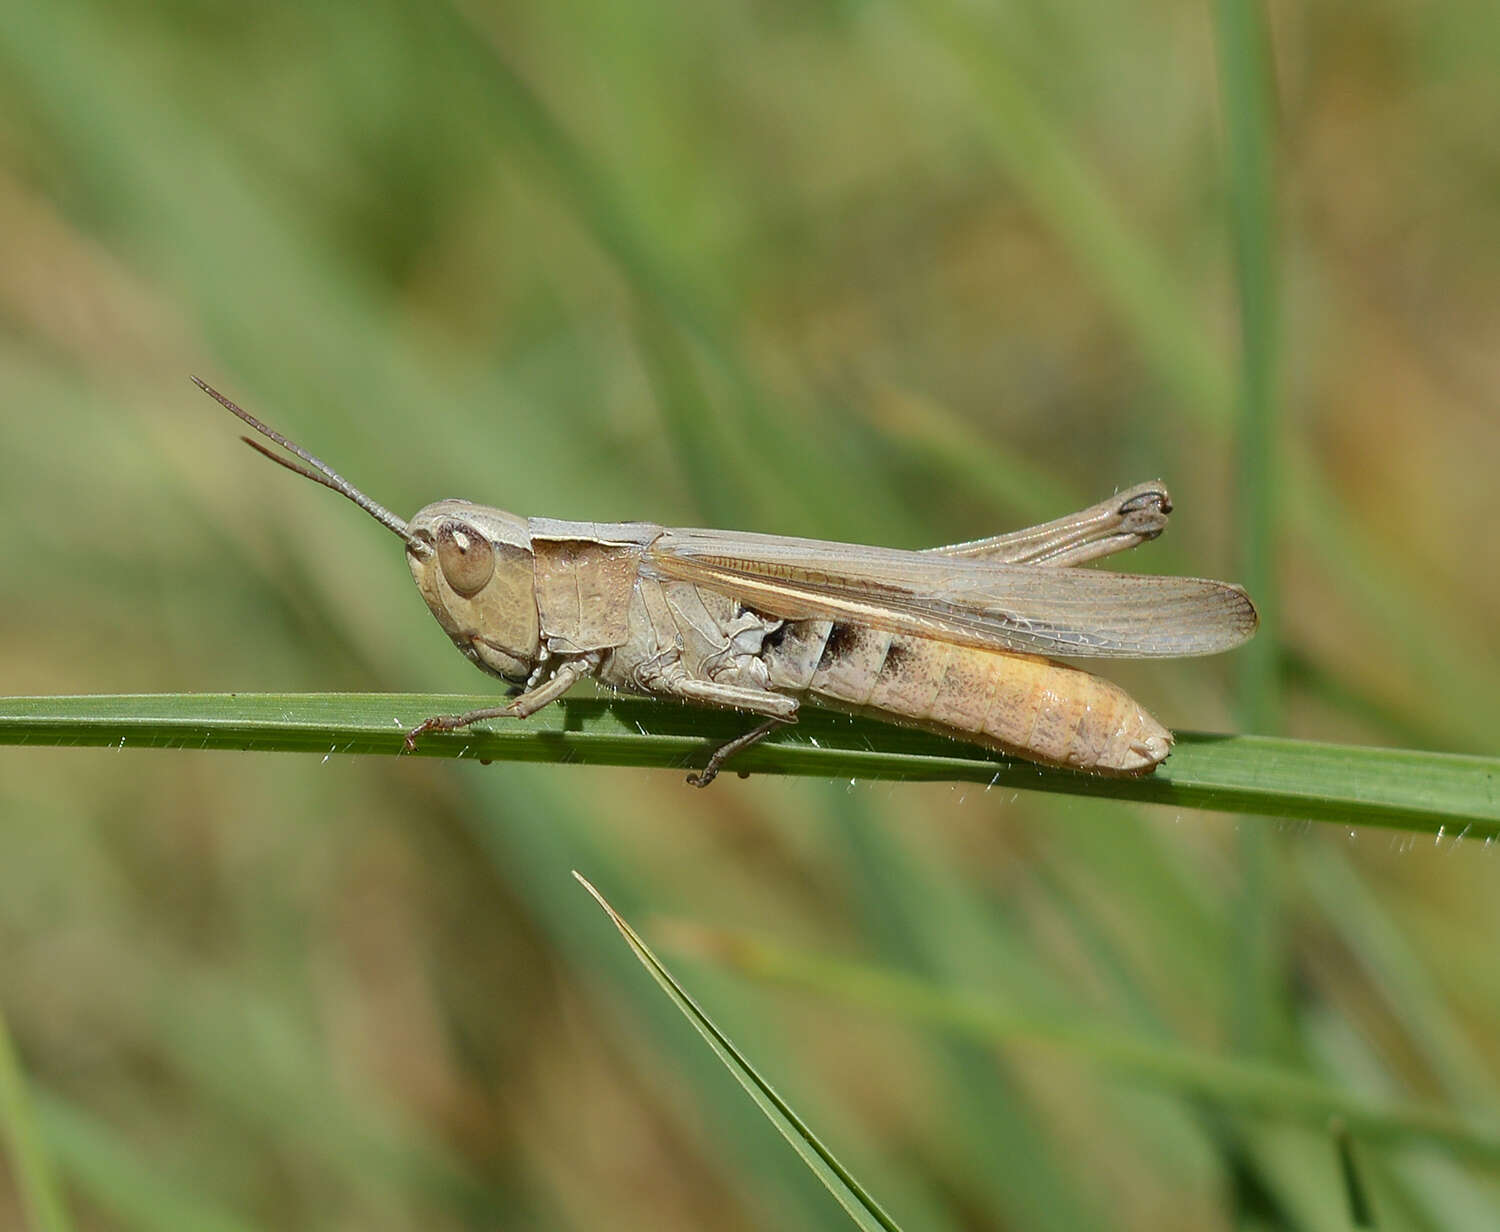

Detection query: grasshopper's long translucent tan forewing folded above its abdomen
xmin=644 ymin=530 xmax=1257 ymax=659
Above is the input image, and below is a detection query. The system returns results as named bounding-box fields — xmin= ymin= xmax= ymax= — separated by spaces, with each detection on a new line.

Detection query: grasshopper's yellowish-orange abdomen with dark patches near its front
xmin=762 ymin=621 xmax=1172 ymax=774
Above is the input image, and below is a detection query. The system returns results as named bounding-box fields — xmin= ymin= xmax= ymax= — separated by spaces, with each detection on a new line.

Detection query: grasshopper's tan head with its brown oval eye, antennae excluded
xmin=407 ymin=501 xmax=542 ymax=683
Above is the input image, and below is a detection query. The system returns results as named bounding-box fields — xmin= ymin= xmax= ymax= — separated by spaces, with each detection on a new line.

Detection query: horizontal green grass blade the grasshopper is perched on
xmin=0 ymin=693 xmax=1500 ymax=840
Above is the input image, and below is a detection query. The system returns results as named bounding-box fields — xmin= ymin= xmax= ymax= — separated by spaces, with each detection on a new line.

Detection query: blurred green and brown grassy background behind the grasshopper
xmin=0 ymin=0 xmax=1500 ymax=1229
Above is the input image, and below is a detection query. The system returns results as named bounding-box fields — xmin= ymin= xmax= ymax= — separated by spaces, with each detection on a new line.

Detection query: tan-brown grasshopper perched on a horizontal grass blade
xmin=194 ymin=377 xmax=1257 ymax=786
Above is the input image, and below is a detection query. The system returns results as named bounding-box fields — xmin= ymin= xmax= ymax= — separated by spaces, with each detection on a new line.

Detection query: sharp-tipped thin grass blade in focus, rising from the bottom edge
xmin=573 ymin=872 xmax=899 ymax=1232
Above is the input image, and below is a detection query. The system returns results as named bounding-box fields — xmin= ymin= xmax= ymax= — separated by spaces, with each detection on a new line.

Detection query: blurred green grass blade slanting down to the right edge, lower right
xmin=695 ymin=930 xmax=1500 ymax=1167
